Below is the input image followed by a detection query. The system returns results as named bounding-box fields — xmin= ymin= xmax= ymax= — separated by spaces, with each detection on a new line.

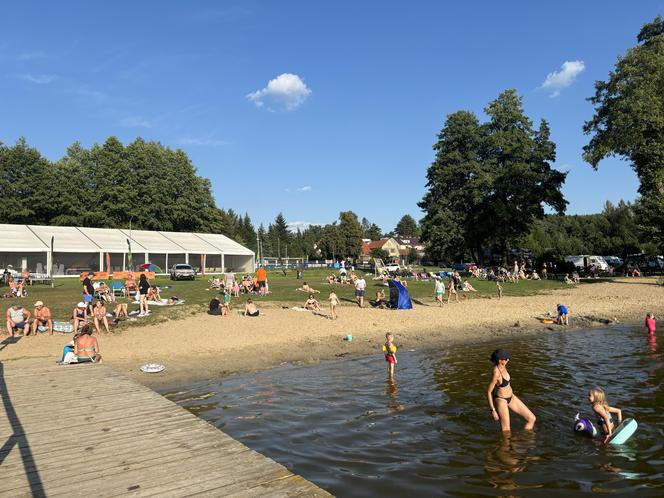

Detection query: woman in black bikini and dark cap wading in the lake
xmin=487 ymin=349 xmax=536 ymax=432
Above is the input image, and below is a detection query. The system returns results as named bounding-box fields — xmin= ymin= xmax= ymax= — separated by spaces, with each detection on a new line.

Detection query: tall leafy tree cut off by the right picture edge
xmin=583 ymin=16 xmax=664 ymax=247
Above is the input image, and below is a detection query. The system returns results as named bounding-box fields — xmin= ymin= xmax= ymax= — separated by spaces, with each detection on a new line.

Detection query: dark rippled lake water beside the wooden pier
xmin=162 ymin=326 xmax=664 ymax=498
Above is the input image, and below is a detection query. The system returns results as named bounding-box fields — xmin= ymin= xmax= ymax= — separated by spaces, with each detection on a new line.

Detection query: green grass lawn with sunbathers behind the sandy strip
xmin=2 ymin=269 xmax=564 ymax=330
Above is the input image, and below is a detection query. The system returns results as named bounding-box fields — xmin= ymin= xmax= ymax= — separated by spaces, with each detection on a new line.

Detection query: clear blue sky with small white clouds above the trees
xmin=0 ymin=0 xmax=664 ymax=230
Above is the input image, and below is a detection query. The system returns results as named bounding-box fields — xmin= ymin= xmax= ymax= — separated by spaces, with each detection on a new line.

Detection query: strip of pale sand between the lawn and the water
xmin=0 ymin=278 xmax=664 ymax=387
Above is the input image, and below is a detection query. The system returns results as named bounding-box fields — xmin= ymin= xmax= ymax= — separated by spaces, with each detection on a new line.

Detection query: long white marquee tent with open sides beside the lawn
xmin=0 ymin=224 xmax=254 ymax=277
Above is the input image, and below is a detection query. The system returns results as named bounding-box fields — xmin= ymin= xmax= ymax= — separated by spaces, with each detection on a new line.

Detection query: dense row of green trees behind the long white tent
xmin=0 ymin=137 xmax=255 ymax=243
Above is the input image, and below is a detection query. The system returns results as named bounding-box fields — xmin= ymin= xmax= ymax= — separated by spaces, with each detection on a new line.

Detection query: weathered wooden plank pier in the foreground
xmin=0 ymin=360 xmax=331 ymax=497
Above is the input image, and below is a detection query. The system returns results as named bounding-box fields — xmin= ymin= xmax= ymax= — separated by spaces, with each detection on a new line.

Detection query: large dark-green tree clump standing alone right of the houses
xmin=418 ymin=90 xmax=567 ymax=262
